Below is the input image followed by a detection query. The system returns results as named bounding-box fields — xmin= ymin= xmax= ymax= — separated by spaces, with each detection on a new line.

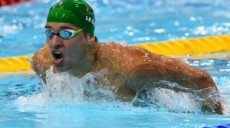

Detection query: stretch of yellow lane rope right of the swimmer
xmin=136 ymin=34 xmax=230 ymax=56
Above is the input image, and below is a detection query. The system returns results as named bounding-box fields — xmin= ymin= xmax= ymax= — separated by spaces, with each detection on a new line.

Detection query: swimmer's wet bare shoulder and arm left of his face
xmin=31 ymin=44 xmax=52 ymax=82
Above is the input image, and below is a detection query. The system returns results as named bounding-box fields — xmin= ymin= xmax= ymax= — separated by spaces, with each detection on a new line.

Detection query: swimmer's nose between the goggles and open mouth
xmin=47 ymin=35 xmax=64 ymax=49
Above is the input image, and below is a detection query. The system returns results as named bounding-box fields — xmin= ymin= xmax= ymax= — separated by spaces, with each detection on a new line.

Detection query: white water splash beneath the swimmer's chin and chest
xmin=15 ymin=68 xmax=115 ymax=105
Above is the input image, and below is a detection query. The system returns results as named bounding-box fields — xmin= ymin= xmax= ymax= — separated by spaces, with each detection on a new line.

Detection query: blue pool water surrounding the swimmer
xmin=0 ymin=0 xmax=230 ymax=128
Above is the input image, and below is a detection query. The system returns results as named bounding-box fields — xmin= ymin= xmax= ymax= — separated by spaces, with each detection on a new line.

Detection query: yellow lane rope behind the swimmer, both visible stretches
xmin=0 ymin=34 xmax=230 ymax=73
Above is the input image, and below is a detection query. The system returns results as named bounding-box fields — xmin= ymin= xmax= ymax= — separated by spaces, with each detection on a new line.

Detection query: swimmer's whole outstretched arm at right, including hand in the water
xmin=127 ymin=64 xmax=224 ymax=114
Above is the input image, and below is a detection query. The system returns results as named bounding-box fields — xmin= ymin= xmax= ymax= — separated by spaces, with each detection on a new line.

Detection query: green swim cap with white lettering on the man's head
xmin=47 ymin=0 xmax=95 ymax=35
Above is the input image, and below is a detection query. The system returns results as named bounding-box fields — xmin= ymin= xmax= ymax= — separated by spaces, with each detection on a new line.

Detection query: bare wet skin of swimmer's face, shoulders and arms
xmin=32 ymin=22 xmax=223 ymax=114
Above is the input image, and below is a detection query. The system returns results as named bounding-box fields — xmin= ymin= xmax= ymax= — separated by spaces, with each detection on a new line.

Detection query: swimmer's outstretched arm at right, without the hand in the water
xmin=128 ymin=60 xmax=217 ymax=92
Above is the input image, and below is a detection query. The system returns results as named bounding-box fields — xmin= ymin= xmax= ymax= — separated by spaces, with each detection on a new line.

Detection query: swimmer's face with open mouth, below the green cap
xmin=45 ymin=22 xmax=88 ymax=72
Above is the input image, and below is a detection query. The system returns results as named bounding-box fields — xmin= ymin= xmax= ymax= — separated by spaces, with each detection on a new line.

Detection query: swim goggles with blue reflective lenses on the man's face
xmin=45 ymin=29 xmax=82 ymax=39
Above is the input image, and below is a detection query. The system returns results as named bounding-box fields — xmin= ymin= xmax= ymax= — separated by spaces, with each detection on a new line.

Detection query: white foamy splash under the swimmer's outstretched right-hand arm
xmin=132 ymin=80 xmax=226 ymax=113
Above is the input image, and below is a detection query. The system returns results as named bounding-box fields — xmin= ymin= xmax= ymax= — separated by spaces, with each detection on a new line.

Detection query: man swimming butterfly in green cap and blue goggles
xmin=32 ymin=0 xmax=223 ymax=114
